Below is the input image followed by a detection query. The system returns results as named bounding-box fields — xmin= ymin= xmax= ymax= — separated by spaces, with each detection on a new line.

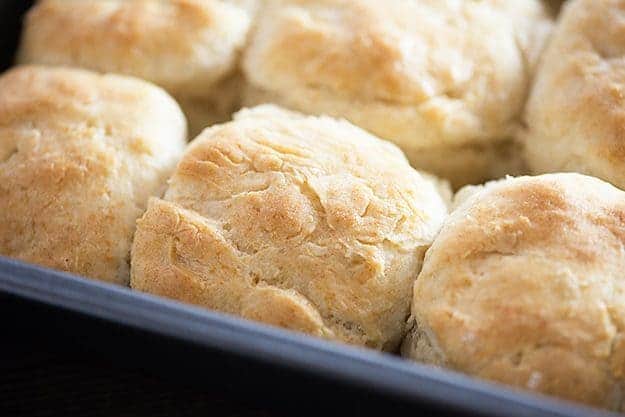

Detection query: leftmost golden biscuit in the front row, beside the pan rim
xmin=0 ymin=66 xmax=186 ymax=285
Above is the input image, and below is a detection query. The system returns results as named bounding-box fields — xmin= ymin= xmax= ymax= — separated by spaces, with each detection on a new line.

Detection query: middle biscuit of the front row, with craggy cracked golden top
xmin=131 ymin=106 xmax=447 ymax=350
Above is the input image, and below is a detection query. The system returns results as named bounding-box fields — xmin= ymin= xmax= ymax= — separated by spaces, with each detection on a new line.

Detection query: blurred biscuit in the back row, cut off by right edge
xmin=524 ymin=0 xmax=625 ymax=189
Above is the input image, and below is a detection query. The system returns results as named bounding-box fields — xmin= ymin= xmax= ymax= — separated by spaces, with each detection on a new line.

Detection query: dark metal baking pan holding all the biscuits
xmin=0 ymin=0 xmax=614 ymax=417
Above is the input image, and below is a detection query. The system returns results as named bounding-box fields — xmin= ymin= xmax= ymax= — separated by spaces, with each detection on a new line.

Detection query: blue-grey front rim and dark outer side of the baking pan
xmin=0 ymin=258 xmax=616 ymax=417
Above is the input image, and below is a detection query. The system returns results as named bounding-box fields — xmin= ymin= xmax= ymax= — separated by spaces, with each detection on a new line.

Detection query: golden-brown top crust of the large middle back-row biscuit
xmin=244 ymin=0 xmax=549 ymax=144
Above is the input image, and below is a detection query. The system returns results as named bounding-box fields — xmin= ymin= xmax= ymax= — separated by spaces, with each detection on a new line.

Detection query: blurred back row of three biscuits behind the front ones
xmin=30 ymin=0 xmax=625 ymax=192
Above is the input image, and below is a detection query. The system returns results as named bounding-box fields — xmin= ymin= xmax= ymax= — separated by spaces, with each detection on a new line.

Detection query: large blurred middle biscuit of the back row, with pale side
xmin=243 ymin=0 xmax=551 ymax=186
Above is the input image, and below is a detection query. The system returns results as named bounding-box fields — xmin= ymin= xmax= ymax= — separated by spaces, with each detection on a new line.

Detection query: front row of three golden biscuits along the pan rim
xmin=0 ymin=63 xmax=625 ymax=409
